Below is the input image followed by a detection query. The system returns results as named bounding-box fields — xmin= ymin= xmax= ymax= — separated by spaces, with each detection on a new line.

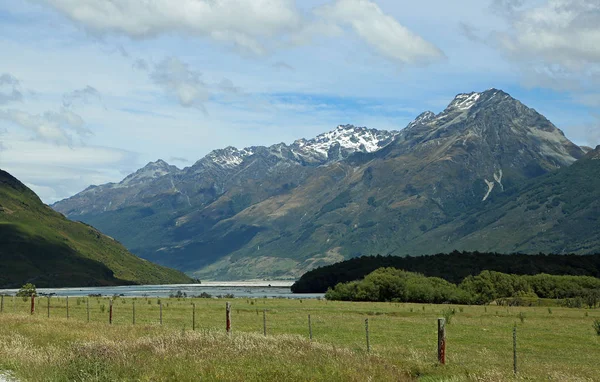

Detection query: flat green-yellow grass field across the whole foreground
xmin=0 ymin=297 xmax=600 ymax=381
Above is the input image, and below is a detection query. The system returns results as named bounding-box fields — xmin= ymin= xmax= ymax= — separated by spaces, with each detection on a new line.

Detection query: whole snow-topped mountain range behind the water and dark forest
xmin=52 ymin=89 xmax=600 ymax=279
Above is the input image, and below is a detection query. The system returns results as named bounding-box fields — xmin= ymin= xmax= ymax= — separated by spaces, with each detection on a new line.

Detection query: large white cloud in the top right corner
xmin=494 ymin=0 xmax=600 ymax=87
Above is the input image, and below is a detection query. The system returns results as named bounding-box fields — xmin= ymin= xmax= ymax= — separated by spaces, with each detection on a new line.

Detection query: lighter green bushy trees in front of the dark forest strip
xmin=325 ymin=268 xmax=600 ymax=308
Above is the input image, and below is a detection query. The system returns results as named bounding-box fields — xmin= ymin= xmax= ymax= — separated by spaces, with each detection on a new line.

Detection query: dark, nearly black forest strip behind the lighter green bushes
xmin=292 ymin=251 xmax=600 ymax=293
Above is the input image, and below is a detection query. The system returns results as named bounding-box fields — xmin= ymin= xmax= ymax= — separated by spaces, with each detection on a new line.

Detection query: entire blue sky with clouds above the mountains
xmin=0 ymin=0 xmax=600 ymax=203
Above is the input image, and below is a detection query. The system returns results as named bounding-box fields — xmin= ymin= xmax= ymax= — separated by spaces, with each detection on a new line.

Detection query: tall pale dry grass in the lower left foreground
xmin=0 ymin=314 xmax=410 ymax=381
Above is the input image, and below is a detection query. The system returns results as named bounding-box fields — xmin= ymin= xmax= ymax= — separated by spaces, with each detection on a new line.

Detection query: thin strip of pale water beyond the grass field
xmin=0 ymin=281 xmax=324 ymax=298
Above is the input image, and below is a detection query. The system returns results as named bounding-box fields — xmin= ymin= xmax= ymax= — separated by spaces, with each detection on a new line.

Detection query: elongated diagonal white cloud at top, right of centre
xmin=317 ymin=0 xmax=444 ymax=65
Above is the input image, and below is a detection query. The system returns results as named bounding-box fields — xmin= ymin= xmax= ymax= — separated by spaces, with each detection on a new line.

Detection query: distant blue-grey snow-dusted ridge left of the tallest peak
xmin=53 ymin=125 xmax=398 ymax=215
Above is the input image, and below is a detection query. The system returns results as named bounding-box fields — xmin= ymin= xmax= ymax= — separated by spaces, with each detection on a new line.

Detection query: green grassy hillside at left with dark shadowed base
xmin=0 ymin=170 xmax=191 ymax=288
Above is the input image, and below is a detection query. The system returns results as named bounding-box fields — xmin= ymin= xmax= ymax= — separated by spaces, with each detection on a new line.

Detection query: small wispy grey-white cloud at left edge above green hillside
xmin=0 ymin=108 xmax=92 ymax=146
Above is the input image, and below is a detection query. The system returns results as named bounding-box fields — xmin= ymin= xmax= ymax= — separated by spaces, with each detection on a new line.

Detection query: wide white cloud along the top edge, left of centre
xmin=32 ymin=0 xmax=301 ymax=54
